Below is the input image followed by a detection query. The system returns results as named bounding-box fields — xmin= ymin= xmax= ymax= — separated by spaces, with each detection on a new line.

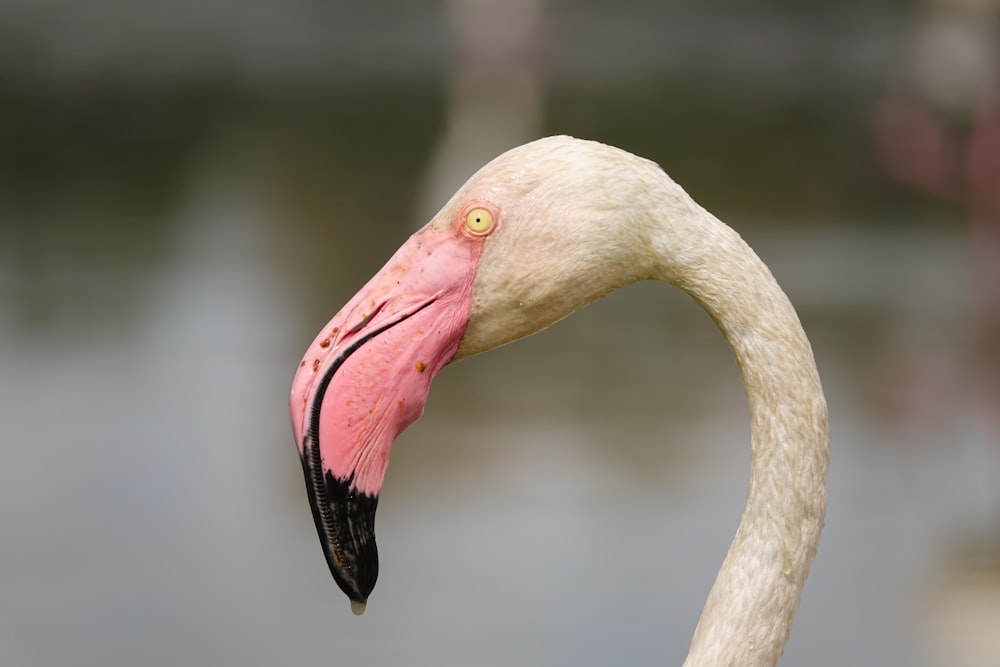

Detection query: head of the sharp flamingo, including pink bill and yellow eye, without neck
xmin=289 ymin=137 xmax=664 ymax=613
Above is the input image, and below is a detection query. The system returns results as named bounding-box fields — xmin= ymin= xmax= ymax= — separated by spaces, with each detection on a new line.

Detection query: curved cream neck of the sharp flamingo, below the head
xmin=650 ymin=205 xmax=829 ymax=666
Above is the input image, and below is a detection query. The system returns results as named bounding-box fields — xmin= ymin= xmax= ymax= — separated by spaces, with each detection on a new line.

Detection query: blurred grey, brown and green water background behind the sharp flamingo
xmin=0 ymin=0 xmax=1000 ymax=667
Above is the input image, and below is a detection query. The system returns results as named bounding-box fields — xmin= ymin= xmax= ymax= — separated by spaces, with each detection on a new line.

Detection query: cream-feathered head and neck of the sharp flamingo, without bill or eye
xmin=455 ymin=137 xmax=829 ymax=667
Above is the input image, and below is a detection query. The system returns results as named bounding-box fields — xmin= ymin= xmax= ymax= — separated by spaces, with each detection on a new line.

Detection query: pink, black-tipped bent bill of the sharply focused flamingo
xmin=289 ymin=223 xmax=483 ymax=603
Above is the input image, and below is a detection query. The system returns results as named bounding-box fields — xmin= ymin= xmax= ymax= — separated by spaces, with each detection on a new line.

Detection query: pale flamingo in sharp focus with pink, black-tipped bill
xmin=289 ymin=136 xmax=829 ymax=666
